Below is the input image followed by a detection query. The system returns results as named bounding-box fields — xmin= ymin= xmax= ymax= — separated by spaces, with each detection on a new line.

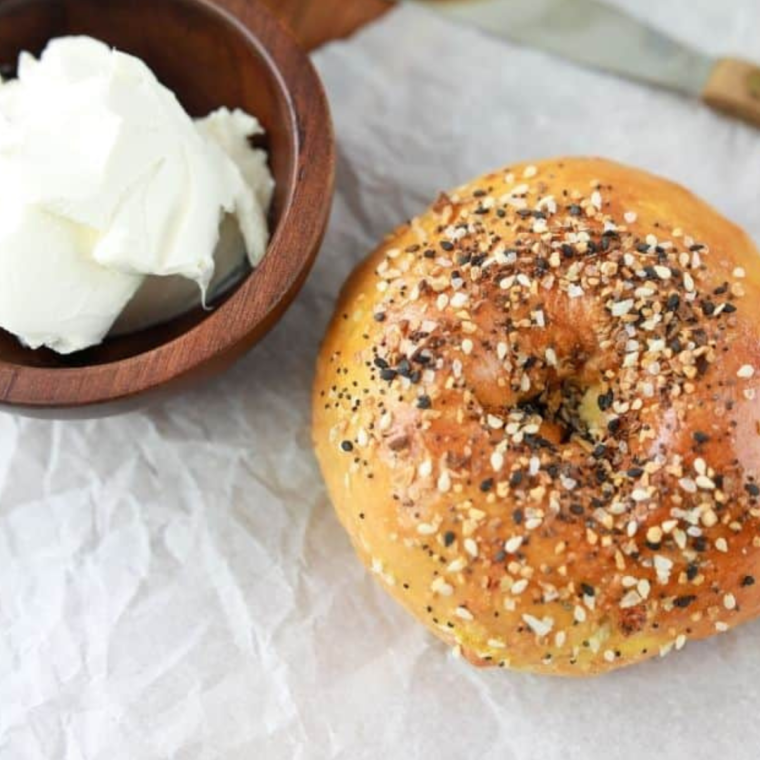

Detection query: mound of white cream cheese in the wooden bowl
xmin=0 ymin=37 xmax=273 ymax=353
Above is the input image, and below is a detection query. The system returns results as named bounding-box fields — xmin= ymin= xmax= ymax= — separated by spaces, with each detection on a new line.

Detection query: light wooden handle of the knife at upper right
xmin=702 ymin=58 xmax=760 ymax=127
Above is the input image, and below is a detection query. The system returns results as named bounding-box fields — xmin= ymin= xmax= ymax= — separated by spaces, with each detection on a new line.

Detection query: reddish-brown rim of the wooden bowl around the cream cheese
xmin=0 ymin=0 xmax=335 ymax=411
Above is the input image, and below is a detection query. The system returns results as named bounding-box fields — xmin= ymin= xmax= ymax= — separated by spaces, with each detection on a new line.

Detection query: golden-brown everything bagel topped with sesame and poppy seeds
xmin=314 ymin=159 xmax=760 ymax=675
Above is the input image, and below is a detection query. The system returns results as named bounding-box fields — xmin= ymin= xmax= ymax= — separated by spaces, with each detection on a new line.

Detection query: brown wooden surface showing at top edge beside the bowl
xmin=265 ymin=0 xmax=390 ymax=50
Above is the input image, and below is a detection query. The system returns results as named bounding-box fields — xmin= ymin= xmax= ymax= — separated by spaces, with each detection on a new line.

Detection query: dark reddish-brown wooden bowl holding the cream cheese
xmin=0 ymin=0 xmax=334 ymax=418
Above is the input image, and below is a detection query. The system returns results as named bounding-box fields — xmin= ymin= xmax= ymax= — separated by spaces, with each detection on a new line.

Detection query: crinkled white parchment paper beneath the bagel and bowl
xmin=0 ymin=0 xmax=760 ymax=760
